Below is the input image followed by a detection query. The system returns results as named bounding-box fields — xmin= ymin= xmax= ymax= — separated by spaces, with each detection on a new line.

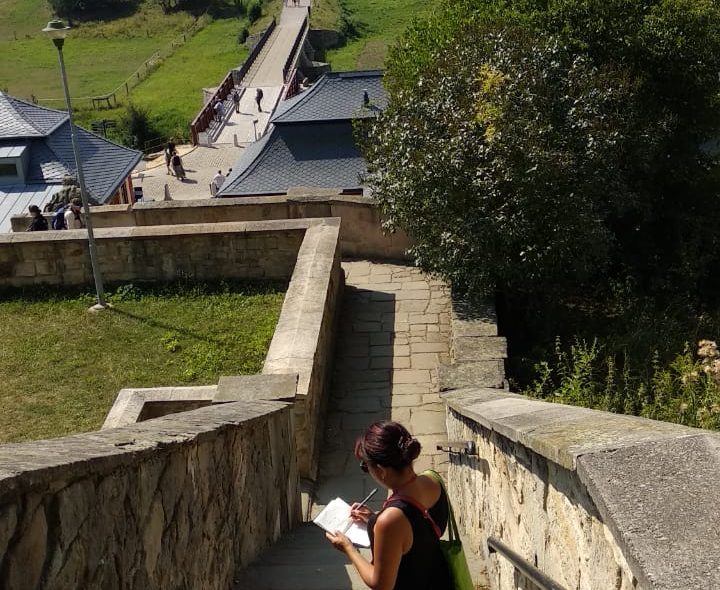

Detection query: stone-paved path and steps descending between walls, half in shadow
xmin=236 ymin=261 xmax=450 ymax=590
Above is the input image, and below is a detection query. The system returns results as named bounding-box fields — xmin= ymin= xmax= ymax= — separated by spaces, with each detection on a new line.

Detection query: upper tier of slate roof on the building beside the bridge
xmin=271 ymin=70 xmax=387 ymax=125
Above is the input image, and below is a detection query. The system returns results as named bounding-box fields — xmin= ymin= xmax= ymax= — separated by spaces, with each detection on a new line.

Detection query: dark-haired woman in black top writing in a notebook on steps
xmin=326 ymin=422 xmax=451 ymax=590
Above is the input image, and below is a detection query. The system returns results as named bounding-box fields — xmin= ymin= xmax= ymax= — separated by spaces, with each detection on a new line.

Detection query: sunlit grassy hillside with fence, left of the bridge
xmin=0 ymin=0 xmax=270 ymax=139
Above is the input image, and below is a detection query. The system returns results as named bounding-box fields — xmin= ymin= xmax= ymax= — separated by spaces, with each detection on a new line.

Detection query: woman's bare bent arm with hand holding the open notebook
xmin=326 ymin=508 xmax=412 ymax=590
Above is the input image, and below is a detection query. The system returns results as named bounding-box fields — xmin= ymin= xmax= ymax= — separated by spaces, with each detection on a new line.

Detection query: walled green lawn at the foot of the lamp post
xmin=0 ymin=283 xmax=284 ymax=442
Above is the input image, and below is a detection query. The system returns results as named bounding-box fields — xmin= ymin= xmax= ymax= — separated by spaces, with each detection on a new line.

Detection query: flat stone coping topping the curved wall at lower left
xmin=0 ymin=400 xmax=291 ymax=504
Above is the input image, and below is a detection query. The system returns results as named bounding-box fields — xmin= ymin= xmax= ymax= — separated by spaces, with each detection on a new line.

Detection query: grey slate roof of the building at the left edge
xmin=0 ymin=92 xmax=142 ymax=212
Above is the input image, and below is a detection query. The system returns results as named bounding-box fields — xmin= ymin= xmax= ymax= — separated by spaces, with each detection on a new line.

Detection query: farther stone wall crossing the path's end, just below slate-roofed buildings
xmin=12 ymin=194 xmax=410 ymax=260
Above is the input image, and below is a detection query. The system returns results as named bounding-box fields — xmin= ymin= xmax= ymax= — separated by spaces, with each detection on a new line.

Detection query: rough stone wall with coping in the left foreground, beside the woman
xmin=0 ymin=401 xmax=300 ymax=590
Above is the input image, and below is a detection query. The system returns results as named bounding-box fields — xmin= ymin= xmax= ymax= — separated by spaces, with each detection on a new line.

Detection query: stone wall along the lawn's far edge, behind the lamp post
xmin=0 ymin=220 xmax=308 ymax=287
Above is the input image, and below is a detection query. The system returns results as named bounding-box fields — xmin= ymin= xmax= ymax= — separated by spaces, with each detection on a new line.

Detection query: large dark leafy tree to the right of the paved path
xmin=360 ymin=0 xmax=720 ymax=294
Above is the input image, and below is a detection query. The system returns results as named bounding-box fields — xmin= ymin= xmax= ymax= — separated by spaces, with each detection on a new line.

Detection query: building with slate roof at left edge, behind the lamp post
xmin=0 ymin=92 xmax=142 ymax=232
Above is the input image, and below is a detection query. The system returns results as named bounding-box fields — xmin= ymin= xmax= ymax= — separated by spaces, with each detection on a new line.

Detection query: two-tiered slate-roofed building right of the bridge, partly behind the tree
xmin=218 ymin=70 xmax=387 ymax=197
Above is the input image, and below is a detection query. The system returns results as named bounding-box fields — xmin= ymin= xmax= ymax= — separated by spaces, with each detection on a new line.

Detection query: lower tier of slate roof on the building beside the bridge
xmin=218 ymin=122 xmax=366 ymax=197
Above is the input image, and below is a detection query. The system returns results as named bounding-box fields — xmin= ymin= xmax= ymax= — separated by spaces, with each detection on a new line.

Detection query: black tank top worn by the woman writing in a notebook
xmin=368 ymin=491 xmax=452 ymax=590
